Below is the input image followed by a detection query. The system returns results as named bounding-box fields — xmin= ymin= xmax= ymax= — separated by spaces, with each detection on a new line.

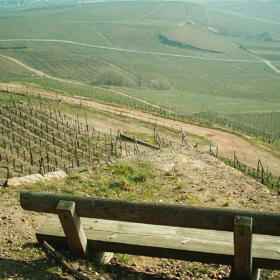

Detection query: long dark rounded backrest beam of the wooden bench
xmin=20 ymin=191 xmax=280 ymax=236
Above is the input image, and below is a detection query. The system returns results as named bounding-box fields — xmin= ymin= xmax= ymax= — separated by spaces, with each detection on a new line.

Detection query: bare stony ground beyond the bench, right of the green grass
xmin=125 ymin=148 xmax=280 ymax=212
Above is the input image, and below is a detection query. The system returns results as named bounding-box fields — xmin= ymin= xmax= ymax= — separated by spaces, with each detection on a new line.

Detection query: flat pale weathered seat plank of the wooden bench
xmin=37 ymin=216 xmax=280 ymax=269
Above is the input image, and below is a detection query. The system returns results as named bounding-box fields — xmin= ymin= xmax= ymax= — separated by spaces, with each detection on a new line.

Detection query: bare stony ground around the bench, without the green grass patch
xmin=0 ymin=148 xmax=280 ymax=280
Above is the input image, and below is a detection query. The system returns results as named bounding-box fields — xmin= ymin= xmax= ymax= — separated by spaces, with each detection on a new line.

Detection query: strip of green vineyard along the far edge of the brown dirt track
xmin=2 ymin=85 xmax=280 ymax=148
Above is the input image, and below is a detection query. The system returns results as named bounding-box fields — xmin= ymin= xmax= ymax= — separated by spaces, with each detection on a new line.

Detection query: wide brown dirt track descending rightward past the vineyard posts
xmin=0 ymin=83 xmax=280 ymax=175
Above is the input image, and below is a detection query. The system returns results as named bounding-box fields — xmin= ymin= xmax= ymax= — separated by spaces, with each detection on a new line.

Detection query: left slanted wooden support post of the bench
xmin=56 ymin=200 xmax=87 ymax=257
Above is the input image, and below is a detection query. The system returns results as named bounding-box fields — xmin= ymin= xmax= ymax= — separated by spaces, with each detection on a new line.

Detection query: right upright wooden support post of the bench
xmin=233 ymin=216 xmax=253 ymax=280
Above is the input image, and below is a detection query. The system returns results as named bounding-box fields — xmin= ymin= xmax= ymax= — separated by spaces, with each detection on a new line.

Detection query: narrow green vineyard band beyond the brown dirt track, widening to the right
xmin=0 ymin=83 xmax=280 ymax=150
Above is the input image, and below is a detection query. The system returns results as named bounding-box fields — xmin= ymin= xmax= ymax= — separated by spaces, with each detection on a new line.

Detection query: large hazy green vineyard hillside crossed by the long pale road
xmin=0 ymin=2 xmax=278 ymax=99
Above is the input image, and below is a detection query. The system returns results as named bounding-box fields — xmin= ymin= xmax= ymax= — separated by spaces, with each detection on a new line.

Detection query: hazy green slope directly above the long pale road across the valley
xmin=0 ymin=2 xmax=255 ymax=59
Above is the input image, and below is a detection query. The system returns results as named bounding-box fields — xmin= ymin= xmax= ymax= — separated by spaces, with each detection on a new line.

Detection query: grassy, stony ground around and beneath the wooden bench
xmin=0 ymin=145 xmax=279 ymax=280
